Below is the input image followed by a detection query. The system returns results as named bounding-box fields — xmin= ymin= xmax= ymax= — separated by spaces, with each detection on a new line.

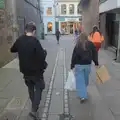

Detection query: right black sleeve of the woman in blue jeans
xmin=91 ymin=42 xmax=99 ymax=66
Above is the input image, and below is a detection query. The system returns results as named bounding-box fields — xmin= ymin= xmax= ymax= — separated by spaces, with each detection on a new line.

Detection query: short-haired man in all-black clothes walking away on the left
xmin=11 ymin=23 xmax=47 ymax=118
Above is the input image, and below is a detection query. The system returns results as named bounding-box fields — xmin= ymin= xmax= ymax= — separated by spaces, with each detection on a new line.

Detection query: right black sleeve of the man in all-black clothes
xmin=35 ymin=40 xmax=47 ymax=64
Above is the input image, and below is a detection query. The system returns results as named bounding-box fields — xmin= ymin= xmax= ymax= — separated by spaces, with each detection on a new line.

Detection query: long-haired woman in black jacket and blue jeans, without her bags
xmin=71 ymin=33 xmax=99 ymax=103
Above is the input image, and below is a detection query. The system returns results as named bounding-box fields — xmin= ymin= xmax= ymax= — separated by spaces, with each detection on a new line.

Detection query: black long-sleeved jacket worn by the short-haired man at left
xmin=11 ymin=35 xmax=47 ymax=76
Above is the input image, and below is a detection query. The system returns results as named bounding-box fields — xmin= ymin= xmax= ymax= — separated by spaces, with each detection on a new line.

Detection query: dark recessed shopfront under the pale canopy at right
xmin=100 ymin=12 xmax=119 ymax=48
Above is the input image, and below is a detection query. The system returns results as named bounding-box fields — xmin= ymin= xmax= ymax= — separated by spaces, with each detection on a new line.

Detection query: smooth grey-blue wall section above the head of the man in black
xmin=16 ymin=0 xmax=40 ymax=35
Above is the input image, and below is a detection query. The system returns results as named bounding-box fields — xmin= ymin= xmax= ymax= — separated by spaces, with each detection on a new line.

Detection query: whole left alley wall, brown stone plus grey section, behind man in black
xmin=0 ymin=0 xmax=40 ymax=67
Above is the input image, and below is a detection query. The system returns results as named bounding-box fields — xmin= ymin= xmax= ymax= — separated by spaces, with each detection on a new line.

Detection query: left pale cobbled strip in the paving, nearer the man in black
xmin=42 ymin=50 xmax=60 ymax=120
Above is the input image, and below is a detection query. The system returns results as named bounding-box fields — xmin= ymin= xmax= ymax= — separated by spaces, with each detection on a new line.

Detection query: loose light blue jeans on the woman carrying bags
xmin=75 ymin=65 xmax=91 ymax=99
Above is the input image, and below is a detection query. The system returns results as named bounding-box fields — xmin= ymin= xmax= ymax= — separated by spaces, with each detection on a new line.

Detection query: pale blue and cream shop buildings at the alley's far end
xmin=40 ymin=0 xmax=81 ymax=34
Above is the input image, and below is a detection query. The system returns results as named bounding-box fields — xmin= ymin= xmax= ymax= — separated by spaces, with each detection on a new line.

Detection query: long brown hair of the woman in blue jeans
xmin=77 ymin=32 xmax=88 ymax=50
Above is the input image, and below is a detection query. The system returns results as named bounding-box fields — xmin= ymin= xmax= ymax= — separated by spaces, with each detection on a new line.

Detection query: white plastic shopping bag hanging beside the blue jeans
xmin=65 ymin=70 xmax=76 ymax=91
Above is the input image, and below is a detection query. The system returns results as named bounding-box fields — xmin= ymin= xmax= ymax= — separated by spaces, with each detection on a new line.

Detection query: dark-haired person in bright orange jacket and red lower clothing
xmin=88 ymin=26 xmax=104 ymax=51
